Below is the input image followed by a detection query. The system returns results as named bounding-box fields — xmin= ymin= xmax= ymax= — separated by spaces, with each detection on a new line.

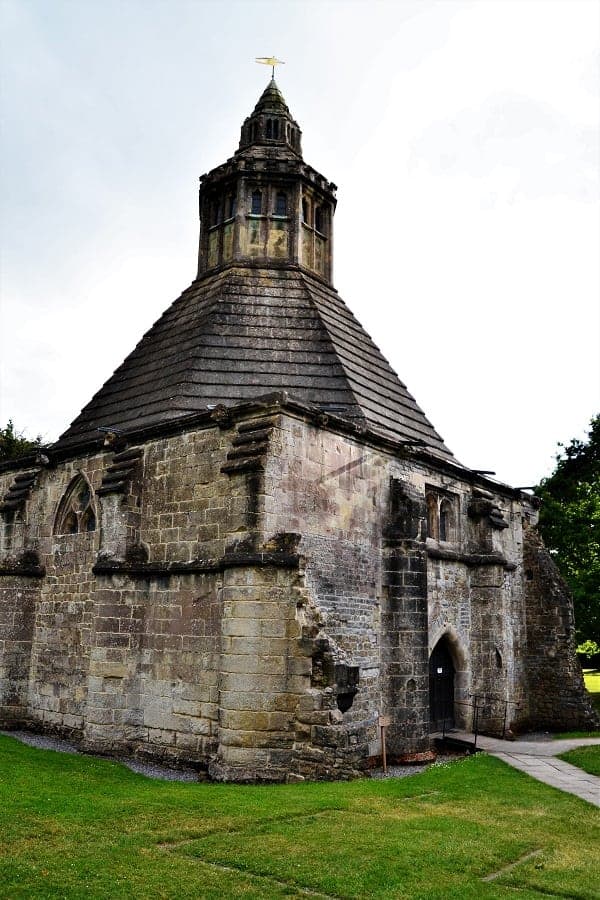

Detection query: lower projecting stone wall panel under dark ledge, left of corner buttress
xmin=84 ymin=574 xmax=221 ymax=766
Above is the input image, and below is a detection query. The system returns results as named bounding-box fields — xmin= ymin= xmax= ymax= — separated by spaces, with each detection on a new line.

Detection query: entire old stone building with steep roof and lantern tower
xmin=0 ymin=80 xmax=593 ymax=781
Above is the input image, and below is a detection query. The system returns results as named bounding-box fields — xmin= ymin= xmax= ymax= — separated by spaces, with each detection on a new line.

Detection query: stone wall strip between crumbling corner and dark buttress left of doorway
xmin=264 ymin=416 xmax=389 ymax=761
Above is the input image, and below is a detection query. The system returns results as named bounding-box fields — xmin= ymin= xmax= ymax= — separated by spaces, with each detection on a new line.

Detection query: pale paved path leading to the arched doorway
xmin=436 ymin=731 xmax=600 ymax=806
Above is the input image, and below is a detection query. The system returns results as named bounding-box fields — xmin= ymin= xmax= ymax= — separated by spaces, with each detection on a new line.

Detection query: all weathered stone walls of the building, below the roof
xmin=0 ymin=401 xmax=592 ymax=781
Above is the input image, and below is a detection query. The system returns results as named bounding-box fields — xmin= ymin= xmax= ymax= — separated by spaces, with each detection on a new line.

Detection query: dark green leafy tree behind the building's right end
xmin=536 ymin=415 xmax=600 ymax=643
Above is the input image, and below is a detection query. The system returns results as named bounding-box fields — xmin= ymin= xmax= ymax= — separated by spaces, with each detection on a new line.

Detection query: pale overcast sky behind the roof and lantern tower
xmin=0 ymin=0 xmax=600 ymax=485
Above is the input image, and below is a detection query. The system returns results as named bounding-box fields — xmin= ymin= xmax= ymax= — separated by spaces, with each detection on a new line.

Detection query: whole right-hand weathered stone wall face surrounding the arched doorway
xmin=265 ymin=417 xmax=544 ymax=757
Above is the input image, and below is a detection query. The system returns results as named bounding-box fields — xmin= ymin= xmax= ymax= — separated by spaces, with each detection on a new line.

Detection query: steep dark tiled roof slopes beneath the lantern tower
xmin=55 ymin=267 xmax=452 ymax=458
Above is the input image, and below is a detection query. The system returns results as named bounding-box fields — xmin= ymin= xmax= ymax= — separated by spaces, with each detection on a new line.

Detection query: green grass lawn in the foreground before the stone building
xmin=0 ymin=737 xmax=600 ymax=900
